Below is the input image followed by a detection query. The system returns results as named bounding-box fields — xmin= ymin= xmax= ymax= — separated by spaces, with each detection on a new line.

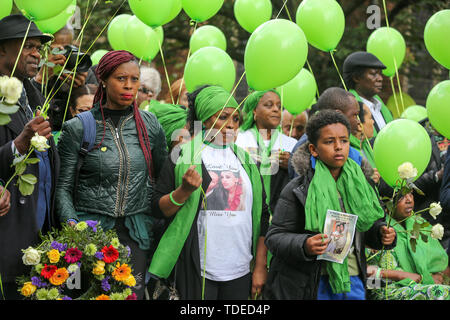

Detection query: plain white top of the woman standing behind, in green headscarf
xmin=236 ymin=130 xmax=297 ymax=175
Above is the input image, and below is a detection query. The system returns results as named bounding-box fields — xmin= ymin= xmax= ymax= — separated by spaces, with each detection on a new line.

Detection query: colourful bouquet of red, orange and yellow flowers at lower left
xmin=17 ymin=220 xmax=136 ymax=300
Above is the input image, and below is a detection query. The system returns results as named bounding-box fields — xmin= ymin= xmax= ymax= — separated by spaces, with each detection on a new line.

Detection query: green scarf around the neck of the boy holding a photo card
xmin=305 ymin=158 xmax=384 ymax=293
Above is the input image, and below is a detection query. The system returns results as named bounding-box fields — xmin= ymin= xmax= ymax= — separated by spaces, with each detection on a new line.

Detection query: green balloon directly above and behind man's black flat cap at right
xmin=367 ymin=27 xmax=406 ymax=77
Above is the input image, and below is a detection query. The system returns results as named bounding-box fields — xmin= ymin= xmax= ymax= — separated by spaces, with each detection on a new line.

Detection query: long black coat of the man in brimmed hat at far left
xmin=0 ymin=80 xmax=59 ymax=282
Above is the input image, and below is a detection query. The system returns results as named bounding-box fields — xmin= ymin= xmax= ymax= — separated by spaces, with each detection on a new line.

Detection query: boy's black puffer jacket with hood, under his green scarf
xmin=264 ymin=144 xmax=395 ymax=300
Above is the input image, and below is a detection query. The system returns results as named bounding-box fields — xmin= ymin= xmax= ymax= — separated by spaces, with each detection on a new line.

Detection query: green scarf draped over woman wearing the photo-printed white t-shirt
xmin=149 ymin=134 xmax=262 ymax=278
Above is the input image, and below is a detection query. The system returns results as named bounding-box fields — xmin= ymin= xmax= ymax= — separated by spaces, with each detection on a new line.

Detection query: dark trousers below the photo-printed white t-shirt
xmin=202 ymin=273 xmax=252 ymax=300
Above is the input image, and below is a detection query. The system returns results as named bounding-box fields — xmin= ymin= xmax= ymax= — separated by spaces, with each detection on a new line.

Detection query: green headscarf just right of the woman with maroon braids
xmin=148 ymin=100 xmax=188 ymax=146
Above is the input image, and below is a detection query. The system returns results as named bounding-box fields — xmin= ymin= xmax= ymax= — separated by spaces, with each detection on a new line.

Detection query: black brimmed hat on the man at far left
xmin=0 ymin=14 xmax=53 ymax=43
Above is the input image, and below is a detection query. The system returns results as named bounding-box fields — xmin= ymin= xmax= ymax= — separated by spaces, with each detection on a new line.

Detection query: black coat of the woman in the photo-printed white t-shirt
xmin=151 ymin=152 xmax=269 ymax=300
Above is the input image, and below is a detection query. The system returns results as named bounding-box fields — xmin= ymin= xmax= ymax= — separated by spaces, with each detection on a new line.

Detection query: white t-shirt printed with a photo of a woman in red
xmin=197 ymin=146 xmax=253 ymax=281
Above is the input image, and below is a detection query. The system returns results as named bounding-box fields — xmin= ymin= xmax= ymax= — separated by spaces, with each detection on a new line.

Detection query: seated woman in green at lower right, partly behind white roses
xmin=368 ymin=193 xmax=450 ymax=300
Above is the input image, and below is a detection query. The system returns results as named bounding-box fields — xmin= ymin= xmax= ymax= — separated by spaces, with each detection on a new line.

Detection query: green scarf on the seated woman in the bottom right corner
xmin=393 ymin=218 xmax=448 ymax=284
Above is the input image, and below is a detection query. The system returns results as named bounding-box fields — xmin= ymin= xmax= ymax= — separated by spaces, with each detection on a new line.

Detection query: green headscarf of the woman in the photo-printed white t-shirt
xmin=195 ymin=86 xmax=239 ymax=122
